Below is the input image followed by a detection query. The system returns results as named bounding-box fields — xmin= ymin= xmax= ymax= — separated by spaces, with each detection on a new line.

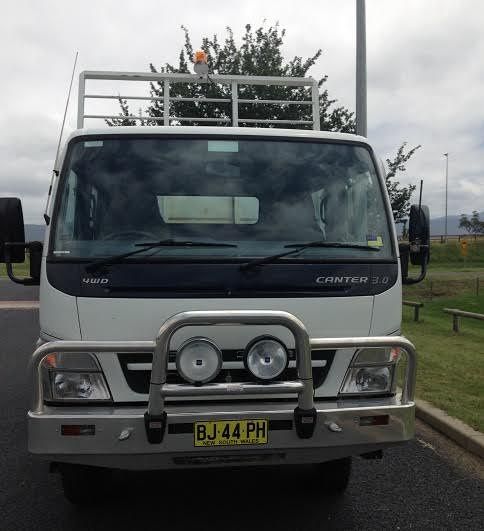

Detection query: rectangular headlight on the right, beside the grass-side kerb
xmin=340 ymin=347 xmax=400 ymax=394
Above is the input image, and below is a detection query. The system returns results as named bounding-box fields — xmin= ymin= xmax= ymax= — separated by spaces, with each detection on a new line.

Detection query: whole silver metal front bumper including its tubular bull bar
xmin=29 ymin=310 xmax=416 ymax=469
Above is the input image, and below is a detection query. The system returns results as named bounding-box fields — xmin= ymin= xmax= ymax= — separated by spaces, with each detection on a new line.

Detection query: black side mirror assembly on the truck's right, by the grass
xmin=398 ymin=205 xmax=430 ymax=284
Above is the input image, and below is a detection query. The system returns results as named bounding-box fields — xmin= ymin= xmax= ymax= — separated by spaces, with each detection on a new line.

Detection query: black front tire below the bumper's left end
xmin=59 ymin=464 xmax=111 ymax=505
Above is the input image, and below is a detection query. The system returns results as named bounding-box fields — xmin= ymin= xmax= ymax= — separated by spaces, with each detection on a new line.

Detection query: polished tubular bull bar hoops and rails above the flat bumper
xmin=32 ymin=310 xmax=417 ymax=444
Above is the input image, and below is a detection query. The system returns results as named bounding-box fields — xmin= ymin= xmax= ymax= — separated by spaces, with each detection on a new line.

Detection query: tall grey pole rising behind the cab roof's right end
xmin=356 ymin=0 xmax=367 ymax=136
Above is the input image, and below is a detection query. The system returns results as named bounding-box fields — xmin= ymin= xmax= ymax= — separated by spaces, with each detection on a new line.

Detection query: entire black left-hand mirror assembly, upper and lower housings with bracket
xmin=0 ymin=197 xmax=42 ymax=286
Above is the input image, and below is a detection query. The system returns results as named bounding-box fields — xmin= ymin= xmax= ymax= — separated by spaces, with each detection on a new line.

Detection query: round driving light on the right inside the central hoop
xmin=244 ymin=336 xmax=289 ymax=380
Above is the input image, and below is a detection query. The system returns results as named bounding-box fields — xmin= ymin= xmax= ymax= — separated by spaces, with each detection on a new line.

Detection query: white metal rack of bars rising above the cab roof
xmin=77 ymin=71 xmax=320 ymax=131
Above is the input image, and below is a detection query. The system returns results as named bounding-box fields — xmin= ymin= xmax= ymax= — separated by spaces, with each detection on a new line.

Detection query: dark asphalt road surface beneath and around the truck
xmin=0 ymin=284 xmax=484 ymax=531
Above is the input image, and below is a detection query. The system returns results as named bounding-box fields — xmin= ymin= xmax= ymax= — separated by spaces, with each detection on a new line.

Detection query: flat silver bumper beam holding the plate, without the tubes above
xmin=28 ymin=398 xmax=415 ymax=470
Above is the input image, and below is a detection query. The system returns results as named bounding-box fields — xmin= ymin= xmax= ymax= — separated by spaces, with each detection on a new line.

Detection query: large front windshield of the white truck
xmin=51 ymin=135 xmax=392 ymax=260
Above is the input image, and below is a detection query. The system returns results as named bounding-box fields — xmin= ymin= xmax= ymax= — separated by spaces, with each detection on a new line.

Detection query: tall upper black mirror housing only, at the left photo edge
xmin=0 ymin=197 xmax=25 ymax=264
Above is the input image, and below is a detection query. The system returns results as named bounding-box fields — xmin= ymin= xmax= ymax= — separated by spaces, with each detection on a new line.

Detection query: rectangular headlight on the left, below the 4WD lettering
xmin=41 ymin=352 xmax=111 ymax=401
